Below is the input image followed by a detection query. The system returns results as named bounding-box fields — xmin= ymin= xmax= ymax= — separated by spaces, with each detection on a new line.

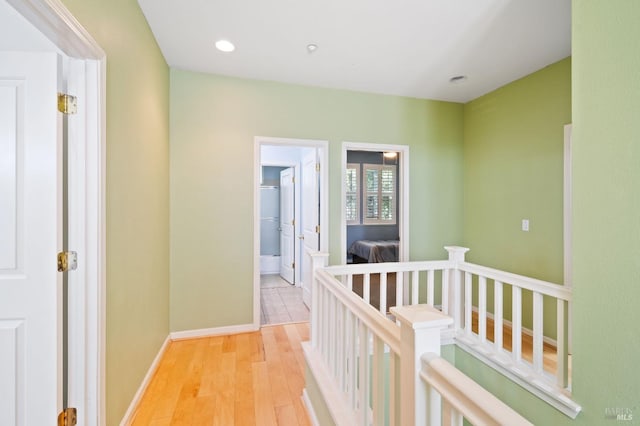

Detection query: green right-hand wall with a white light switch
xmin=464 ymin=58 xmax=571 ymax=338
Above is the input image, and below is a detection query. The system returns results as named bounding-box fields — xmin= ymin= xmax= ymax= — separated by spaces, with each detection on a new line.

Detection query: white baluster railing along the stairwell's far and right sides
xmin=312 ymin=246 xmax=580 ymax=418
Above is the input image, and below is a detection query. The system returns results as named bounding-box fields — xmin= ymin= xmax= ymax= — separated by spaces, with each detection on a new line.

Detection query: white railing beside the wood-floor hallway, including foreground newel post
xmin=304 ymin=251 xmax=528 ymax=426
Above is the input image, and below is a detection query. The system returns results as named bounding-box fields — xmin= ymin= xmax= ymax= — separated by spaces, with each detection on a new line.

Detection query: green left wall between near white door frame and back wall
xmin=58 ymin=0 xmax=169 ymax=425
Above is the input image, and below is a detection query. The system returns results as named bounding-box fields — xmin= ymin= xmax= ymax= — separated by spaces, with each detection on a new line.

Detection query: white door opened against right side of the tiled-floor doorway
xmin=301 ymin=149 xmax=320 ymax=306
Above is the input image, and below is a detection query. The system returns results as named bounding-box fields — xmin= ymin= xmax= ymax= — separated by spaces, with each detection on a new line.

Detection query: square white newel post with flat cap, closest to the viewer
xmin=391 ymin=305 xmax=453 ymax=425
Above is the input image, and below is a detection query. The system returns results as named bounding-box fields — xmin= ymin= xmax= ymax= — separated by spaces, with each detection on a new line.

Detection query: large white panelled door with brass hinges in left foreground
xmin=0 ymin=52 xmax=62 ymax=426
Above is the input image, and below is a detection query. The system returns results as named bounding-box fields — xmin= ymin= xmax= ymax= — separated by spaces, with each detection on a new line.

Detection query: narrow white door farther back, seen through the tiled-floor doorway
xmin=280 ymin=168 xmax=295 ymax=284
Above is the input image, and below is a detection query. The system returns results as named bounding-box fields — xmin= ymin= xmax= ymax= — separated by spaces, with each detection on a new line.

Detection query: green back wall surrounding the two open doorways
xmin=170 ymin=69 xmax=462 ymax=331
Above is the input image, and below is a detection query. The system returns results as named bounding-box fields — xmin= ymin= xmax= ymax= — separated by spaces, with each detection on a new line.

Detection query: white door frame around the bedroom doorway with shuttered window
xmin=340 ymin=142 xmax=409 ymax=263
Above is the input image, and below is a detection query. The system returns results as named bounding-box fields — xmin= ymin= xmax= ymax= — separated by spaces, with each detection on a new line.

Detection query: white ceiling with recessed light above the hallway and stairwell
xmin=138 ymin=0 xmax=571 ymax=102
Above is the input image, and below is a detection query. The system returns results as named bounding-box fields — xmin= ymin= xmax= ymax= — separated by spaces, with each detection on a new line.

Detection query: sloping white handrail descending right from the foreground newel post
xmin=420 ymin=352 xmax=532 ymax=426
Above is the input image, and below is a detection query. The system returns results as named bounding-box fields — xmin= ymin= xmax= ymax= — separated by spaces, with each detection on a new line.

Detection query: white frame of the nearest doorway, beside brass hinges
xmin=7 ymin=0 xmax=106 ymax=425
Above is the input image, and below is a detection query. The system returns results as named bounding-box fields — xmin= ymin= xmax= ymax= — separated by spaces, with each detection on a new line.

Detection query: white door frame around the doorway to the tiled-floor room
xmin=253 ymin=136 xmax=329 ymax=330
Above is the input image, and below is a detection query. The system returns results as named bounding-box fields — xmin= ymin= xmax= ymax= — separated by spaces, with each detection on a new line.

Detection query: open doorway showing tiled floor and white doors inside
xmin=254 ymin=137 xmax=328 ymax=327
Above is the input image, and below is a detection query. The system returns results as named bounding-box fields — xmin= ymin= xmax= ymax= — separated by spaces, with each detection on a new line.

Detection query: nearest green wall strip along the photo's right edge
xmin=572 ymin=0 xmax=640 ymax=424
